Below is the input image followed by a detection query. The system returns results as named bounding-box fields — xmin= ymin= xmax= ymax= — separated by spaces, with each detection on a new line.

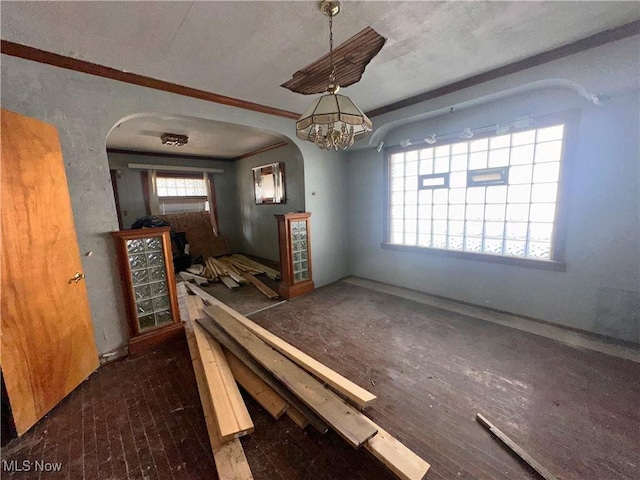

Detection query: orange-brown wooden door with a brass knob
xmin=0 ymin=109 xmax=99 ymax=435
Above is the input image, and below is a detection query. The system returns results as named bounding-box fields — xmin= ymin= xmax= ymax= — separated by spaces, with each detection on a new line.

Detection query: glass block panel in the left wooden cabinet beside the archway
xmin=127 ymin=237 xmax=173 ymax=333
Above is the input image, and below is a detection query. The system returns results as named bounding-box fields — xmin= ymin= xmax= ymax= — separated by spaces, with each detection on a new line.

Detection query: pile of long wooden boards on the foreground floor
xmin=178 ymin=283 xmax=429 ymax=480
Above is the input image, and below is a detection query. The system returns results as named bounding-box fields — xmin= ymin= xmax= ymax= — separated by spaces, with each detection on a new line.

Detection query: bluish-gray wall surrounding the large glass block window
xmin=348 ymin=37 xmax=640 ymax=342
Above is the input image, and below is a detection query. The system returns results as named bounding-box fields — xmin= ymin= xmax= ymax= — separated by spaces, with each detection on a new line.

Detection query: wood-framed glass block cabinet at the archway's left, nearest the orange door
xmin=111 ymin=227 xmax=182 ymax=355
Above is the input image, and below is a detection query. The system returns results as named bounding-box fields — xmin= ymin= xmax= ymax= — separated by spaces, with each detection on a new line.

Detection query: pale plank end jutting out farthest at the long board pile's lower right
xmin=364 ymin=418 xmax=431 ymax=480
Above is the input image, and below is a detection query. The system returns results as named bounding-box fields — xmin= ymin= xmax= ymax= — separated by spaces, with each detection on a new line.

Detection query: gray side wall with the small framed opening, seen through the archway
xmin=233 ymin=145 xmax=304 ymax=261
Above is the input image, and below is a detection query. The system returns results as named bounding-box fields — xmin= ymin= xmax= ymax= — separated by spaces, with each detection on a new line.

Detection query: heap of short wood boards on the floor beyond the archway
xmin=179 ymin=254 xmax=280 ymax=299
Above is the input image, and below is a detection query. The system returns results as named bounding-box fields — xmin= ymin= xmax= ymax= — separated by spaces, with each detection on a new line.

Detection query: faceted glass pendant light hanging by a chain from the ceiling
xmin=296 ymin=0 xmax=373 ymax=150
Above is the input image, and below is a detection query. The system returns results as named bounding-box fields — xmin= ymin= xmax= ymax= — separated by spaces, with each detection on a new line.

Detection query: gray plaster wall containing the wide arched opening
xmin=1 ymin=55 xmax=348 ymax=353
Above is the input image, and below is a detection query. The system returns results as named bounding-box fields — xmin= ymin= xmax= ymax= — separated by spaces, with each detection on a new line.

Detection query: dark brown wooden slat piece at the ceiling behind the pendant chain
xmin=280 ymin=27 xmax=386 ymax=95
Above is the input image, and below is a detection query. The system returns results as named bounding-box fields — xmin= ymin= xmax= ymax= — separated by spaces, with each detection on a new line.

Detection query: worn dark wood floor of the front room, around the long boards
xmin=2 ymin=282 xmax=640 ymax=480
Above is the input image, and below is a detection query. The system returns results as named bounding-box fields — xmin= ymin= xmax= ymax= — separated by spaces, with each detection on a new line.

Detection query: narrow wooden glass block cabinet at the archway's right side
xmin=275 ymin=213 xmax=314 ymax=299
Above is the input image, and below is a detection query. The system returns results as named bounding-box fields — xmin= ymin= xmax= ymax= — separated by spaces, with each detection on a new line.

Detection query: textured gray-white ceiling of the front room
xmin=0 ymin=1 xmax=640 ymax=154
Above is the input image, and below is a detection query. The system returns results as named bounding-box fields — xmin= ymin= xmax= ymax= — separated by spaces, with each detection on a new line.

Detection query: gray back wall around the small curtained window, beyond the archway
xmin=107 ymin=152 xmax=238 ymax=234
